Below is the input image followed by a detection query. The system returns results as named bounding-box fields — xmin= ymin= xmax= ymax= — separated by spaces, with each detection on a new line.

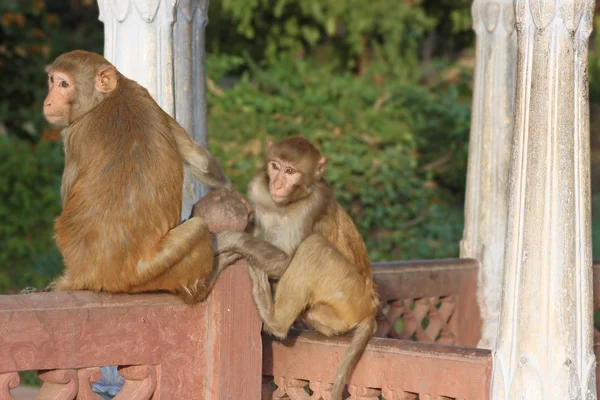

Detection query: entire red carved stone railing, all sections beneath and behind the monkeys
xmin=5 ymin=259 xmax=600 ymax=400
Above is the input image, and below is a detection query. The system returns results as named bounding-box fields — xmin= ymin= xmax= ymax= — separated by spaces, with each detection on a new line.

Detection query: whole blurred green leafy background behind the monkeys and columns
xmin=0 ymin=0 xmax=600 ymax=293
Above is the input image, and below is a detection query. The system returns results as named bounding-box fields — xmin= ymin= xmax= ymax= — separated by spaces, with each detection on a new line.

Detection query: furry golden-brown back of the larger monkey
xmin=55 ymin=78 xmax=183 ymax=291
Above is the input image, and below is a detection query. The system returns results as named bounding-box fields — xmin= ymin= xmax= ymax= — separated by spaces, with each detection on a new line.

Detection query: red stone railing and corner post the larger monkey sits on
xmin=0 ymin=266 xmax=262 ymax=400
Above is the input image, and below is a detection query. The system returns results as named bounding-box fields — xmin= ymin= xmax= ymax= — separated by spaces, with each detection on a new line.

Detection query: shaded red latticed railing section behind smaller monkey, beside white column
xmin=373 ymin=259 xmax=481 ymax=347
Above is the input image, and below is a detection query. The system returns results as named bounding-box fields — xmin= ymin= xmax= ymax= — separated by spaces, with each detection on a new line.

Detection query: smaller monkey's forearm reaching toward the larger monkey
xmin=214 ymin=231 xmax=291 ymax=278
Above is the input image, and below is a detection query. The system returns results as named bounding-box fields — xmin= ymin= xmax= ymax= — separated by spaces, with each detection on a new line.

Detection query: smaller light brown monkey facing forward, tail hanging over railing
xmin=216 ymin=137 xmax=378 ymax=399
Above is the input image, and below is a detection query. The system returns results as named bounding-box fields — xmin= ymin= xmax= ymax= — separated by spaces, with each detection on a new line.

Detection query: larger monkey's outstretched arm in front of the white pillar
xmin=170 ymin=120 xmax=231 ymax=188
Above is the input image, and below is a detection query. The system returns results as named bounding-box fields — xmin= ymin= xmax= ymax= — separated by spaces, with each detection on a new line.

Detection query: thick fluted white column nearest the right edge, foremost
xmin=492 ymin=0 xmax=596 ymax=400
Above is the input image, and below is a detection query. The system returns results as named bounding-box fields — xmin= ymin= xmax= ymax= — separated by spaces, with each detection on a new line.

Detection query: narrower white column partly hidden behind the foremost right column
xmin=460 ymin=0 xmax=517 ymax=348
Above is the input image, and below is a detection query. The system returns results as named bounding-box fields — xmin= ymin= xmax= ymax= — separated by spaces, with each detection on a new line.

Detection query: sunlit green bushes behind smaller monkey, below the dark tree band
xmin=209 ymin=57 xmax=470 ymax=260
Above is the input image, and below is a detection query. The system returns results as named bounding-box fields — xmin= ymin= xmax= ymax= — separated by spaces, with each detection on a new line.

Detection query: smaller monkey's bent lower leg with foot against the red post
xmin=248 ymin=267 xmax=307 ymax=339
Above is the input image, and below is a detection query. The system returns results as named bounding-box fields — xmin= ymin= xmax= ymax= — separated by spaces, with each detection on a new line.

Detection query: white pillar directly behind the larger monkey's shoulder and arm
xmin=98 ymin=0 xmax=208 ymax=218
